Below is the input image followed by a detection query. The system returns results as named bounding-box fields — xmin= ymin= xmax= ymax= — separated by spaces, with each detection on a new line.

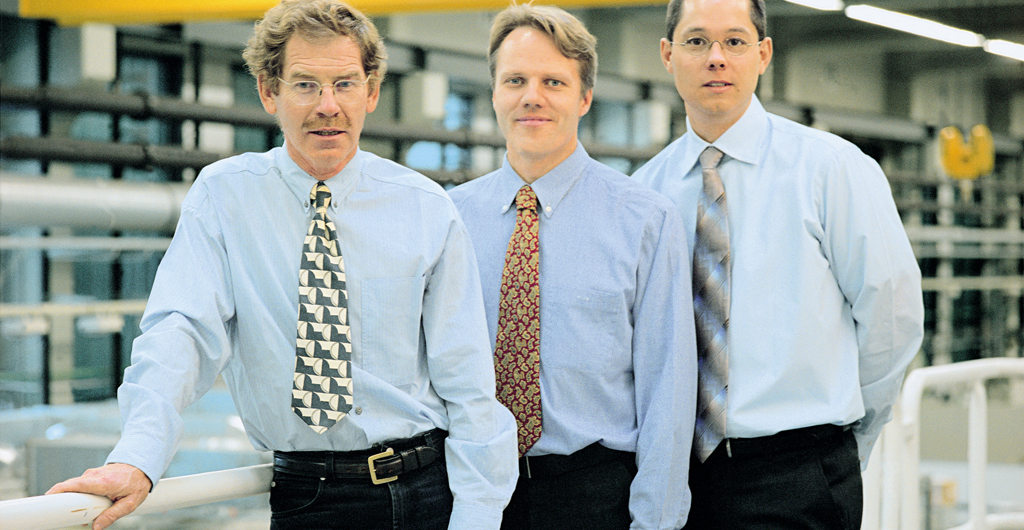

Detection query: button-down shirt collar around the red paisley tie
xmin=497 ymin=140 xmax=590 ymax=219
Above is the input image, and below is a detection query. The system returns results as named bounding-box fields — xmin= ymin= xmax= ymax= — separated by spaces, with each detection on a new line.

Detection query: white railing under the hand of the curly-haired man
xmin=0 ymin=463 xmax=273 ymax=530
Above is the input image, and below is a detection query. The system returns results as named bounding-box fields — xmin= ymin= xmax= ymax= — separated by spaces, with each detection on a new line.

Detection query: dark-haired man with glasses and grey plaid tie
xmin=634 ymin=0 xmax=924 ymax=530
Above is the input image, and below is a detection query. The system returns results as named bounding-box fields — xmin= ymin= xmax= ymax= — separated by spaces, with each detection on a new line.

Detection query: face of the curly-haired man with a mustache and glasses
xmin=259 ymin=35 xmax=380 ymax=180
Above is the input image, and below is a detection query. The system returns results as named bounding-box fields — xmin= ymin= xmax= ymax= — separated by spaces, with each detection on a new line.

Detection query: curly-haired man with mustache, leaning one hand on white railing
xmin=44 ymin=0 xmax=516 ymax=530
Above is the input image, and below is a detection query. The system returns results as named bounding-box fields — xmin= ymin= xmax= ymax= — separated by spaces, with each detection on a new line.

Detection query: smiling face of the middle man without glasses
xmin=492 ymin=27 xmax=593 ymax=181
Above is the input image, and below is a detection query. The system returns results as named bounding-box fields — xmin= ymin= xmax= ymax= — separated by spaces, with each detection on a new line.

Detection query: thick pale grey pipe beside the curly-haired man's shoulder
xmin=0 ymin=173 xmax=188 ymax=233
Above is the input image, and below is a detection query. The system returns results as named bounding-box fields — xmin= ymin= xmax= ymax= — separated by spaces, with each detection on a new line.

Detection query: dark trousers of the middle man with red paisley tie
xmin=502 ymin=444 xmax=637 ymax=530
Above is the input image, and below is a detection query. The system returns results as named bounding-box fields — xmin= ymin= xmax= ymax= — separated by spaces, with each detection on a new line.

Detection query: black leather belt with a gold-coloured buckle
xmin=273 ymin=429 xmax=447 ymax=484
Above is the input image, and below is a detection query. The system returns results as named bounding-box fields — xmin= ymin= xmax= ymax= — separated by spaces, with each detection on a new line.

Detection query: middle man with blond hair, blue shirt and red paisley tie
xmin=450 ymin=5 xmax=696 ymax=530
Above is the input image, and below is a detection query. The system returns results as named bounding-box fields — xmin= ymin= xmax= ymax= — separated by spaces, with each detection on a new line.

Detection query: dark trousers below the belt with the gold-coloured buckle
xmin=270 ymin=452 xmax=452 ymax=530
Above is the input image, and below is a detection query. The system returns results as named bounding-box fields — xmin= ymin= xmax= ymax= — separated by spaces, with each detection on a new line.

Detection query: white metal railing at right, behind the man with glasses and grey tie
xmin=862 ymin=357 xmax=1024 ymax=530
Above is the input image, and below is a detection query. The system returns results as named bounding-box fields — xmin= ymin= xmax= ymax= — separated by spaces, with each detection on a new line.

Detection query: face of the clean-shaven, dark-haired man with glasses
xmin=662 ymin=0 xmax=772 ymax=141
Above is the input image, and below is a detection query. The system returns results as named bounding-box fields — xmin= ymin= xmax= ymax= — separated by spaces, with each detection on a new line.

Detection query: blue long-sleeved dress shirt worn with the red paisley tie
xmin=450 ymin=144 xmax=696 ymax=529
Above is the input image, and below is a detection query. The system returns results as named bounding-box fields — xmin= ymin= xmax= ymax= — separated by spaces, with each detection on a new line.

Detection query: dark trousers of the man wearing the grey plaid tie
xmin=684 ymin=426 xmax=863 ymax=530
